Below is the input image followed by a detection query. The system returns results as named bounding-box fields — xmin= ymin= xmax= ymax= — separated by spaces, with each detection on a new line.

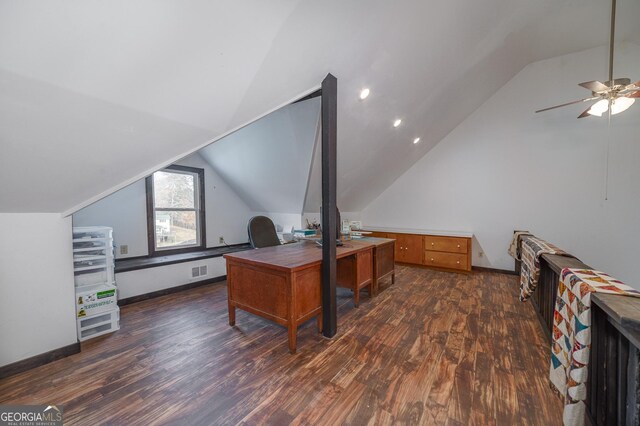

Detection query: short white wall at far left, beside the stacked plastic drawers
xmin=0 ymin=213 xmax=77 ymax=366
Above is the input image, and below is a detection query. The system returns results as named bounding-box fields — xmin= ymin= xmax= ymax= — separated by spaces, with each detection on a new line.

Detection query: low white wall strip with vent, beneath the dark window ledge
xmin=116 ymin=257 xmax=227 ymax=299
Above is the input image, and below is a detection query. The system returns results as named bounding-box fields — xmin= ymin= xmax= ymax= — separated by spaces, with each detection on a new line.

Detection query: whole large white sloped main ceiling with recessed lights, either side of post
xmin=0 ymin=0 xmax=640 ymax=213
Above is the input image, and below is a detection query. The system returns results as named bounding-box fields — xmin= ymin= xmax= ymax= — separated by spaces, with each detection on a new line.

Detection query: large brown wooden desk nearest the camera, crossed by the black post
xmin=224 ymin=241 xmax=374 ymax=353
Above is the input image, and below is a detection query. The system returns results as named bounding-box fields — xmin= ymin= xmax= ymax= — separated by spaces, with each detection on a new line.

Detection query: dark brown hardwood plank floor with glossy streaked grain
xmin=0 ymin=266 xmax=562 ymax=425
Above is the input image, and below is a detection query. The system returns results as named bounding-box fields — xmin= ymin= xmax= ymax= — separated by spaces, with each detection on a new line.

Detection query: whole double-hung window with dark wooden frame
xmin=147 ymin=166 xmax=206 ymax=256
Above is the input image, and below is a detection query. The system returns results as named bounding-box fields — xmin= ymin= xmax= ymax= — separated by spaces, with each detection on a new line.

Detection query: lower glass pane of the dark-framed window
xmin=156 ymin=211 xmax=199 ymax=248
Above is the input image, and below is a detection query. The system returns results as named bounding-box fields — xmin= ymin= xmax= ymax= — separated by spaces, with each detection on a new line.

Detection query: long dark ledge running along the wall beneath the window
xmin=115 ymin=243 xmax=251 ymax=274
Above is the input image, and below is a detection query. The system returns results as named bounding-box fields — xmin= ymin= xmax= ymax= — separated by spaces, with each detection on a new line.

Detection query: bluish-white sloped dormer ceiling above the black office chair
xmin=200 ymin=98 xmax=320 ymax=214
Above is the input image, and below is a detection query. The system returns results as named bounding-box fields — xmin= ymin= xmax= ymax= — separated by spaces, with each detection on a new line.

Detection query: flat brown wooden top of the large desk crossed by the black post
xmin=224 ymin=239 xmax=380 ymax=271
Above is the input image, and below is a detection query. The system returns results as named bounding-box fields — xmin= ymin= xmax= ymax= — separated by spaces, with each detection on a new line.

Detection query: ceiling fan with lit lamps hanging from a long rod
xmin=536 ymin=0 xmax=640 ymax=118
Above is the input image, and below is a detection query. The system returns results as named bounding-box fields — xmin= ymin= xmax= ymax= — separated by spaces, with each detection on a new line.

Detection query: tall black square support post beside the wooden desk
xmin=322 ymin=74 xmax=338 ymax=337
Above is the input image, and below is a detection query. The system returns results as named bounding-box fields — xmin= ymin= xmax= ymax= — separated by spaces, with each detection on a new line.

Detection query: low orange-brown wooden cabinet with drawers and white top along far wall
xmin=364 ymin=227 xmax=473 ymax=272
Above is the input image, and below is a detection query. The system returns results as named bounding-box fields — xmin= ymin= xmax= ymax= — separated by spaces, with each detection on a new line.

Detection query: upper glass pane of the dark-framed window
xmin=153 ymin=172 xmax=195 ymax=209
